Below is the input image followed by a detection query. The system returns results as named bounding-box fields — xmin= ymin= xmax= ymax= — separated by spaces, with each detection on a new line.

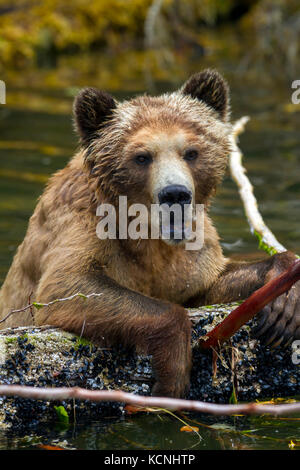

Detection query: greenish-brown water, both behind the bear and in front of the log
xmin=0 ymin=35 xmax=300 ymax=449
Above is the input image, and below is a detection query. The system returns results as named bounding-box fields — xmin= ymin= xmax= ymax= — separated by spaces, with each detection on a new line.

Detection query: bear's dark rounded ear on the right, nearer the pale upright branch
xmin=181 ymin=69 xmax=229 ymax=121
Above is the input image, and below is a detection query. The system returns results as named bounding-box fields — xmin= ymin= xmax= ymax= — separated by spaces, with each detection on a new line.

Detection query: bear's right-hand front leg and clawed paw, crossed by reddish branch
xmin=197 ymin=251 xmax=300 ymax=347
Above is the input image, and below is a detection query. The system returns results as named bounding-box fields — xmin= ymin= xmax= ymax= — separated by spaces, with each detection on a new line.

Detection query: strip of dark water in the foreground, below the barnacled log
xmin=0 ymin=413 xmax=300 ymax=451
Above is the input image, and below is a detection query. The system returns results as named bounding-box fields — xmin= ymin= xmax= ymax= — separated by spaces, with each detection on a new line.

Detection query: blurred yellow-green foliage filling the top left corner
xmin=0 ymin=0 xmax=151 ymax=65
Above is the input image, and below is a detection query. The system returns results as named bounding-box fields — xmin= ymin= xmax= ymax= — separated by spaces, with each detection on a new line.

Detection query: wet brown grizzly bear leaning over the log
xmin=0 ymin=70 xmax=300 ymax=397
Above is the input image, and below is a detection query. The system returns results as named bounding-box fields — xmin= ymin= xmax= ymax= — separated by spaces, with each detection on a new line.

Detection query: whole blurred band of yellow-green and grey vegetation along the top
xmin=0 ymin=0 xmax=300 ymax=81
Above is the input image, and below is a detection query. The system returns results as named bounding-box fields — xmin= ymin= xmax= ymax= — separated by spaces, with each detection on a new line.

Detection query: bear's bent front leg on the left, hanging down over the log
xmin=36 ymin=270 xmax=191 ymax=397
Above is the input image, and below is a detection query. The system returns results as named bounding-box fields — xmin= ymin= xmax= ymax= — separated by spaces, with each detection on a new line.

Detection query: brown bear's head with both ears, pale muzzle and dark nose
xmin=74 ymin=70 xmax=231 ymax=246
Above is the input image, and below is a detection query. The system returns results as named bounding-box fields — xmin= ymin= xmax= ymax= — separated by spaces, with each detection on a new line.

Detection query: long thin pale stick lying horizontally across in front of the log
xmin=0 ymin=385 xmax=300 ymax=416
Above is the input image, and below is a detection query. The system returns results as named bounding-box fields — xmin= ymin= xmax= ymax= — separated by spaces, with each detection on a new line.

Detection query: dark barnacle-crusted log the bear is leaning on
xmin=0 ymin=304 xmax=300 ymax=426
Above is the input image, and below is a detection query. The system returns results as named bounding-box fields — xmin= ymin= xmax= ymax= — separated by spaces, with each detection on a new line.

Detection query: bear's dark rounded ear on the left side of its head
xmin=73 ymin=87 xmax=116 ymax=145
